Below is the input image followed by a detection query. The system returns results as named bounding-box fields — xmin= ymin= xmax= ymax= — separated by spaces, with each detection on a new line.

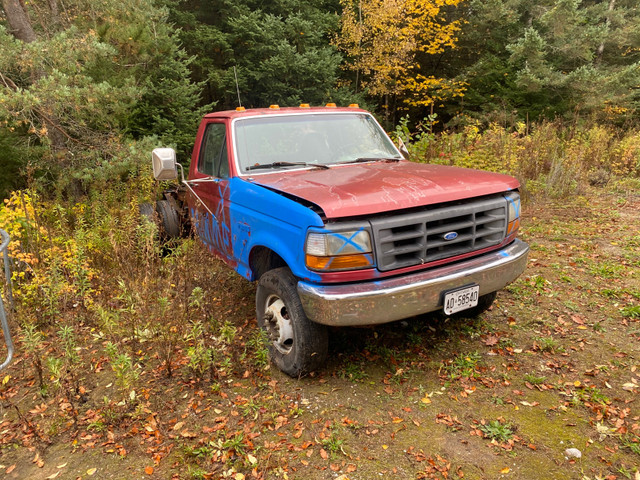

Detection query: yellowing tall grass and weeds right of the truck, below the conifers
xmin=395 ymin=118 xmax=640 ymax=196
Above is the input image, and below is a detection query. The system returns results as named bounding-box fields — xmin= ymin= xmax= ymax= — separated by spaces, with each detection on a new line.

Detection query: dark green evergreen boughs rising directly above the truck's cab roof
xmin=170 ymin=0 xmax=358 ymax=109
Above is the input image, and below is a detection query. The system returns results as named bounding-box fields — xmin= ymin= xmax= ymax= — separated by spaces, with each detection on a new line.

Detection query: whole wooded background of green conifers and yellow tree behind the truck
xmin=0 ymin=0 xmax=640 ymax=196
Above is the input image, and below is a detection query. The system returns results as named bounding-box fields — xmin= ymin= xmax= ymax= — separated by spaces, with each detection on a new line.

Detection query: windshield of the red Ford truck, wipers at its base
xmin=235 ymin=113 xmax=402 ymax=174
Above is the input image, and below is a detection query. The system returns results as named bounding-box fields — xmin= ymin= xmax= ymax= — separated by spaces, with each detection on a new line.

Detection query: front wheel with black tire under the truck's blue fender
xmin=256 ymin=267 xmax=329 ymax=377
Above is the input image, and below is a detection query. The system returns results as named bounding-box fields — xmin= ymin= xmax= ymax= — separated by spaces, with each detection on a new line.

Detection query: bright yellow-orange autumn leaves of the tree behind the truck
xmin=334 ymin=0 xmax=465 ymax=105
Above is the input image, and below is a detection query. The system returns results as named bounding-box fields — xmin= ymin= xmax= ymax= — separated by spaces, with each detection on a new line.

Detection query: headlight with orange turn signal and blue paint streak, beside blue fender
xmin=305 ymin=228 xmax=374 ymax=271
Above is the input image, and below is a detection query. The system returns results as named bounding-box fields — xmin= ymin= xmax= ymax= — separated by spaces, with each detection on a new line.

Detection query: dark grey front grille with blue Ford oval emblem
xmin=371 ymin=195 xmax=507 ymax=271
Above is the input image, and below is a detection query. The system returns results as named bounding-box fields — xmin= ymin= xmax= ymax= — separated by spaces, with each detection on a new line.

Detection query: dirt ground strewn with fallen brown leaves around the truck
xmin=0 ymin=189 xmax=640 ymax=480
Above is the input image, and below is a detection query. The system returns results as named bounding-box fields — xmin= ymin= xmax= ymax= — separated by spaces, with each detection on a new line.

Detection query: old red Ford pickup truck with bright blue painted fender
xmin=152 ymin=104 xmax=529 ymax=377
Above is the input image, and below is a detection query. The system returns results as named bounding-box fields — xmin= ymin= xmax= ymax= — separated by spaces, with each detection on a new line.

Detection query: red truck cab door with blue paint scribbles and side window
xmin=189 ymin=123 xmax=233 ymax=261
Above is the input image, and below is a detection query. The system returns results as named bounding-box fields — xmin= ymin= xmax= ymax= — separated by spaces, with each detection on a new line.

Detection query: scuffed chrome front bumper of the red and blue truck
xmin=298 ymin=240 xmax=529 ymax=326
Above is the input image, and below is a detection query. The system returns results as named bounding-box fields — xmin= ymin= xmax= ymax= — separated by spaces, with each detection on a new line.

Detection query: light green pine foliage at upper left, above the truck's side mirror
xmin=0 ymin=0 xmax=206 ymax=193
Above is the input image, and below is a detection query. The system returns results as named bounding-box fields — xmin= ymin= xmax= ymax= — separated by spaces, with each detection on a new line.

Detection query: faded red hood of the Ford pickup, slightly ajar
xmin=253 ymin=161 xmax=519 ymax=218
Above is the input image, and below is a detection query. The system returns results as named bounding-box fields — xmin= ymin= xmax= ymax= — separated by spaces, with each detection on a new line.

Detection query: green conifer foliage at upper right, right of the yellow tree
xmin=450 ymin=0 xmax=640 ymax=125
